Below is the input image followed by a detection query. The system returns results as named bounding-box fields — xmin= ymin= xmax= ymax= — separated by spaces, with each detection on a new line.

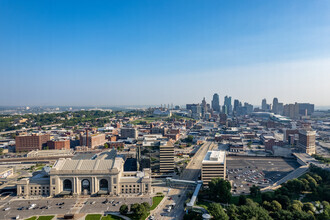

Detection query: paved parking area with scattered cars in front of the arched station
xmin=0 ymin=196 xmax=152 ymax=219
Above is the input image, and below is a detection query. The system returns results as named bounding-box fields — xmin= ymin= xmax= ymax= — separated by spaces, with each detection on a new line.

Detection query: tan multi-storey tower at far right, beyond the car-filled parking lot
xmin=298 ymin=129 xmax=316 ymax=155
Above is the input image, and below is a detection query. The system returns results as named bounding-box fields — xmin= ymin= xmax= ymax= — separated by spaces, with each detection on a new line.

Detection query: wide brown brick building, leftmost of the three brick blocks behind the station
xmin=15 ymin=134 xmax=50 ymax=152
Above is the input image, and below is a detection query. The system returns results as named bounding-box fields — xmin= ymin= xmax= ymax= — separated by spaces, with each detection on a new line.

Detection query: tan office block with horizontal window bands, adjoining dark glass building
xmin=159 ymin=142 xmax=174 ymax=173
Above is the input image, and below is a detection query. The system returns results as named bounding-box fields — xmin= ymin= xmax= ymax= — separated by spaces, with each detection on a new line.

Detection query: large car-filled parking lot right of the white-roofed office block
xmin=227 ymin=157 xmax=299 ymax=194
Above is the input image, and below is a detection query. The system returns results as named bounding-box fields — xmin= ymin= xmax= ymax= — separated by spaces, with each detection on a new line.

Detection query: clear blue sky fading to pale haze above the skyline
xmin=0 ymin=0 xmax=330 ymax=106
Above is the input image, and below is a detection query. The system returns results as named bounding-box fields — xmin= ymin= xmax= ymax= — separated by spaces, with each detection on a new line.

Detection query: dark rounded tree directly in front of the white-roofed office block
xmin=208 ymin=178 xmax=231 ymax=203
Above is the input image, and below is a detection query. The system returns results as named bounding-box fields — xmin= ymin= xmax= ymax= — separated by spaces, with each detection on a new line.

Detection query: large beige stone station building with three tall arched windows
xmin=17 ymin=150 xmax=151 ymax=196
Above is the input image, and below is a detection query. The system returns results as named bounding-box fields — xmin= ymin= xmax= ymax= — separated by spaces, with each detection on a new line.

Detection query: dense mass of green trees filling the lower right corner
xmin=189 ymin=166 xmax=330 ymax=220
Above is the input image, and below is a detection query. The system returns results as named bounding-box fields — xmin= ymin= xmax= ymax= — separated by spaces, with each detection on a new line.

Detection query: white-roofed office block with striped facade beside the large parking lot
xmin=201 ymin=151 xmax=226 ymax=186
